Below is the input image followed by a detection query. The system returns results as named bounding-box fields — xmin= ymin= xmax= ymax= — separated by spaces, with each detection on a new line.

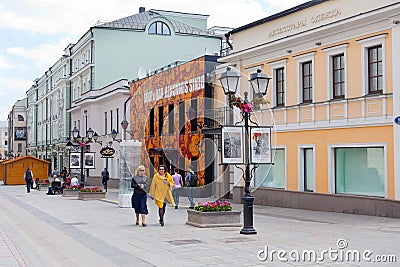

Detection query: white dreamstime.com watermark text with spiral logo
xmin=257 ymin=238 xmax=397 ymax=263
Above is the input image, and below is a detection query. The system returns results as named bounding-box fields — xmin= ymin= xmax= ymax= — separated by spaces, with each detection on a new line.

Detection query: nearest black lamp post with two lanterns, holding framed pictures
xmin=219 ymin=67 xmax=271 ymax=237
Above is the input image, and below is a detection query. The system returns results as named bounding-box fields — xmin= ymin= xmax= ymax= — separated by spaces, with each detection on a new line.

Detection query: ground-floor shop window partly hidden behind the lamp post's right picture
xmin=255 ymin=148 xmax=286 ymax=188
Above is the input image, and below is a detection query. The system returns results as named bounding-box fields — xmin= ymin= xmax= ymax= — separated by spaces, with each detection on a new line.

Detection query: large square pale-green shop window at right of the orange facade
xmin=334 ymin=147 xmax=385 ymax=197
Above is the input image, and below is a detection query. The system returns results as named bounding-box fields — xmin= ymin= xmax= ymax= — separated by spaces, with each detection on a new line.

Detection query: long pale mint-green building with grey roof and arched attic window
xmin=27 ymin=8 xmax=222 ymax=180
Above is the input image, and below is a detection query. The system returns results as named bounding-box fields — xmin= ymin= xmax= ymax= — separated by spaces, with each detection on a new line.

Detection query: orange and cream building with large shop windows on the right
xmin=218 ymin=0 xmax=400 ymax=217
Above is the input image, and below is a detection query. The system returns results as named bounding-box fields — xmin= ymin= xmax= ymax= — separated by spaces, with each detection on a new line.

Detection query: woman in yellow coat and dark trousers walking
xmin=150 ymin=165 xmax=175 ymax=226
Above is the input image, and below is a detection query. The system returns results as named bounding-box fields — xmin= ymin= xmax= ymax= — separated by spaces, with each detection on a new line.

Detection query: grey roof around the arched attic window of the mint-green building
xmin=95 ymin=9 xmax=214 ymax=36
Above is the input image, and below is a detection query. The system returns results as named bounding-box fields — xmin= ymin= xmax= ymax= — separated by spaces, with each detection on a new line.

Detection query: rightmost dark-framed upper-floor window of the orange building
xmin=368 ymin=45 xmax=383 ymax=94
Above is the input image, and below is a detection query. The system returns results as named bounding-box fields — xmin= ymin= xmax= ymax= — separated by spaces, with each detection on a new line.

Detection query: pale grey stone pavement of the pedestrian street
xmin=0 ymin=184 xmax=400 ymax=266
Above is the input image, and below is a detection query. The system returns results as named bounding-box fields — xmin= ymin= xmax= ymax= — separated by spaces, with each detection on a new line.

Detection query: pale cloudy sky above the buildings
xmin=0 ymin=0 xmax=307 ymax=121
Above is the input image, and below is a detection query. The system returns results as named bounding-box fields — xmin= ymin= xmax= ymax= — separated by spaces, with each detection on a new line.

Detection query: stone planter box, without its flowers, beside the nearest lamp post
xmin=186 ymin=209 xmax=241 ymax=228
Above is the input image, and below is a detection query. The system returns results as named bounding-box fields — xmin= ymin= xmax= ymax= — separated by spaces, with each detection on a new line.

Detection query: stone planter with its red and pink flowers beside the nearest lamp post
xmin=186 ymin=200 xmax=241 ymax=227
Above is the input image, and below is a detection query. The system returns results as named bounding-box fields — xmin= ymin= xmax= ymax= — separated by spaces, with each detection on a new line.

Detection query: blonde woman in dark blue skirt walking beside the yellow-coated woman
xmin=131 ymin=165 xmax=149 ymax=227
